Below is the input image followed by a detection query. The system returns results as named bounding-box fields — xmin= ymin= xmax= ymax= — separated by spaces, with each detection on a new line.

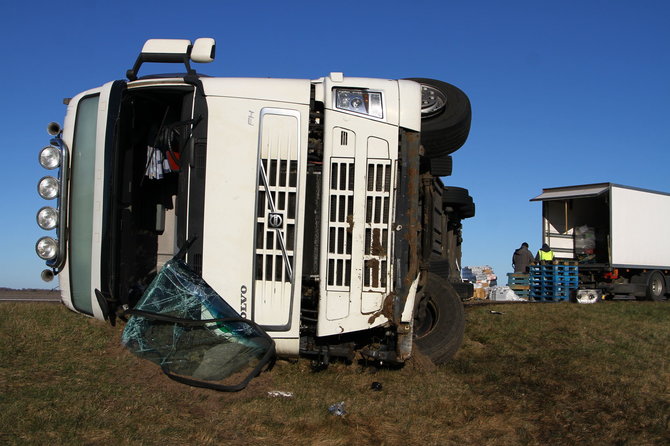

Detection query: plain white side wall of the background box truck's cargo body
xmin=610 ymin=186 xmax=670 ymax=268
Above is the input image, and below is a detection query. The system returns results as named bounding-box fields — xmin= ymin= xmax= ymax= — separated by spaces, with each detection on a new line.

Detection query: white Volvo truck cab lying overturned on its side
xmin=36 ymin=38 xmax=475 ymax=363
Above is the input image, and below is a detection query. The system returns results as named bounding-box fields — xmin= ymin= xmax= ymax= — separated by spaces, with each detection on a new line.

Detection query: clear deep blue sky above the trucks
xmin=0 ymin=0 xmax=670 ymax=288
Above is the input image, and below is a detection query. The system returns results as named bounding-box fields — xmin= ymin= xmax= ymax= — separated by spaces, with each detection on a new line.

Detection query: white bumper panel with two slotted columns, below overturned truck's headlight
xmin=317 ymin=110 xmax=398 ymax=336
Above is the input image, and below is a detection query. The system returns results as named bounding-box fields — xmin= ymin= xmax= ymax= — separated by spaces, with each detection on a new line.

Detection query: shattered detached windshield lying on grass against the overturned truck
xmin=121 ymin=256 xmax=275 ymax=392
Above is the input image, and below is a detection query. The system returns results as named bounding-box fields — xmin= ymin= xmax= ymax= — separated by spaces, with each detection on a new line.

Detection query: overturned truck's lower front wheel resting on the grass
xmin=413 ymin=273 xmax=465 ymax=364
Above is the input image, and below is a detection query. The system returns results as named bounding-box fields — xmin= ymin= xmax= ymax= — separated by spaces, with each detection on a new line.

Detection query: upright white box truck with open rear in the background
xmin=531 ymin=183 xmax=670 ymax=302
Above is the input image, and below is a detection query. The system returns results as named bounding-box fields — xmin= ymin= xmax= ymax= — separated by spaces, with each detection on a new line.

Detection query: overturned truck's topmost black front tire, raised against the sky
xmin=409 ymin=78 xmax=472 ymax=158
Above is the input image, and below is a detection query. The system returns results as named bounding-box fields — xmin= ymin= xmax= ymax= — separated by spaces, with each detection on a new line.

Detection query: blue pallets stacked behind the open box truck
xmin=530 ymin=260 xmax=579 ymax=301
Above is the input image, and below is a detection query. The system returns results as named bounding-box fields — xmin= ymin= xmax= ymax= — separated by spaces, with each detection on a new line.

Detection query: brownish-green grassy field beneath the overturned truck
xmin=0 ymin=302 xmax=670 ymax=446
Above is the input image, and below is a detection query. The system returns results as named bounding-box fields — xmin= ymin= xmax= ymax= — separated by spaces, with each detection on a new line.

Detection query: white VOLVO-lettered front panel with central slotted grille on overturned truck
xmin=203 ymin=96 xmax=309 ymax=337
